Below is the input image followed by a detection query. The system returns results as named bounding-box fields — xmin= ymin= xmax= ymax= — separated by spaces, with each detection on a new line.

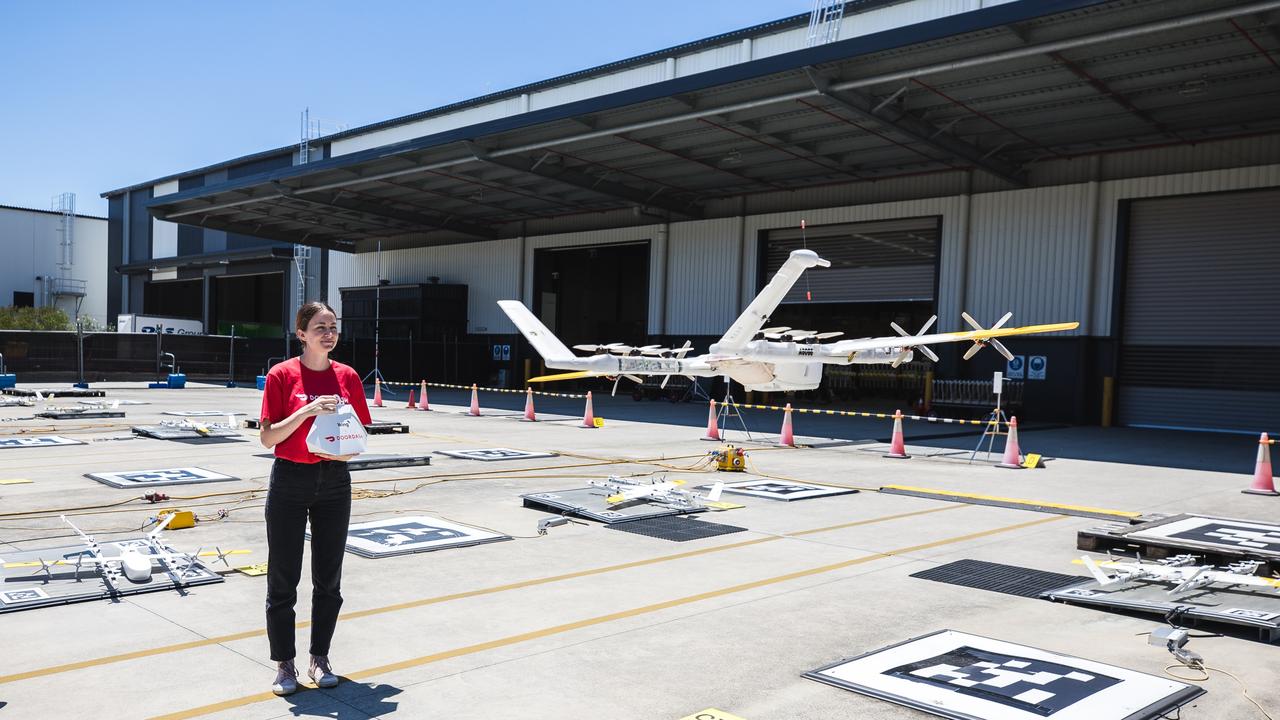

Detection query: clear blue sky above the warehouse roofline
xmin=0 ymin=0 xmax=812 ymax=215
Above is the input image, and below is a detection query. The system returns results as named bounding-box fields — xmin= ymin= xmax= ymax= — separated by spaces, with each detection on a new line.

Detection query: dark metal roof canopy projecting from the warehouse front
xmin=148 ymin=0 xmax=1280 ymax=252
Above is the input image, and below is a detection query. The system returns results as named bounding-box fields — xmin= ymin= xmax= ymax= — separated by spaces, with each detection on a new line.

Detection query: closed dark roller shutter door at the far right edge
xmin=1116 ymin=190 xmax=1280 ymax=432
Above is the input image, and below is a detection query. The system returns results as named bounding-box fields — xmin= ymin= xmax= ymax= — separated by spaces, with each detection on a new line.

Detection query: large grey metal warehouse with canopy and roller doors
xmin=105 ymin=0 xmax=1280 ymax=432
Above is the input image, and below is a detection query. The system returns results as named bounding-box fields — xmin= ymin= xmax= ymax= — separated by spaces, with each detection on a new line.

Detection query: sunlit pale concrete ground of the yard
xmin=0 ymin=383 xmax=1280 ymax=720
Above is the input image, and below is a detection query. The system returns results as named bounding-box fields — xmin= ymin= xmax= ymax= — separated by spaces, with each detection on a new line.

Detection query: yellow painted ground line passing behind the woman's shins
xmin=0 ymin=505 xmax=964 ymax=684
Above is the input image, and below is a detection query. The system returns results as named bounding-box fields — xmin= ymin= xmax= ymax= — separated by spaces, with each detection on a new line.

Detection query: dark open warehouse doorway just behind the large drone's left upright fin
xmin=534 ymin=241 xmax=649 ymax=345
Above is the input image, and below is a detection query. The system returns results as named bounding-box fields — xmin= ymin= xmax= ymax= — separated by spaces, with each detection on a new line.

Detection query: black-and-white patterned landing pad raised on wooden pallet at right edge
xmin=1076 ymin=514 xmax=1280 ymax=571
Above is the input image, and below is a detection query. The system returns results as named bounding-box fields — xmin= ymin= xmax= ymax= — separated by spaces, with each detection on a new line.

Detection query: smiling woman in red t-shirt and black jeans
xmin=261 ymin=302 xmax=371 ymax=696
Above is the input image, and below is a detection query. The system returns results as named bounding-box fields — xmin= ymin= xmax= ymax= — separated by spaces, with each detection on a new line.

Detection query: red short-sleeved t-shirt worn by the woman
xmin=261 ymin=357 xmax=372 ymax=462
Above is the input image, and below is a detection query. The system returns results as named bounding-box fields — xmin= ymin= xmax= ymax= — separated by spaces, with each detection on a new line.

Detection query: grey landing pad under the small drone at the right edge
xmin=1042 ymin=579 xmax=1280 ymax=643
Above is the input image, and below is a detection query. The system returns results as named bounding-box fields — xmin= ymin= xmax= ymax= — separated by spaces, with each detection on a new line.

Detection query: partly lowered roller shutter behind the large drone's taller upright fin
xmin=764 ymin=217 xmax=941 ymax=305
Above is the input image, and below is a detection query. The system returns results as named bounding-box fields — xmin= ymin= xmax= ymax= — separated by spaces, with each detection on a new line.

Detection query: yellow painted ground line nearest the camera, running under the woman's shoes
xmin=151 ymin=516 xmax=1062 ymax=720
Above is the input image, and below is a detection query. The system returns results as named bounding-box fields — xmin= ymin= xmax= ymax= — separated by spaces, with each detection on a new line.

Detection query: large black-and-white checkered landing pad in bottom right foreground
xmin=804 ymin=630 xmax=1204 ymax=720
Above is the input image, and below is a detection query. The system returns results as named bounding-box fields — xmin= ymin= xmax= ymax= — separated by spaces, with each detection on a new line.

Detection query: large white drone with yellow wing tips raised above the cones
xmin=498 ymin=250 xmax=1079 ymax=392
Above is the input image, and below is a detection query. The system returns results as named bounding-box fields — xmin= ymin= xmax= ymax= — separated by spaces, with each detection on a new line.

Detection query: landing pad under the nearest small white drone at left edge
xmin=0 ymin=539 xmax=223 ymax=612
